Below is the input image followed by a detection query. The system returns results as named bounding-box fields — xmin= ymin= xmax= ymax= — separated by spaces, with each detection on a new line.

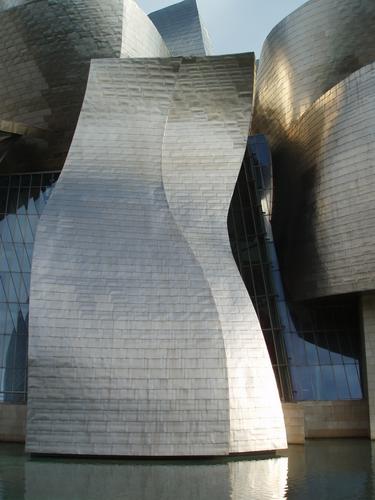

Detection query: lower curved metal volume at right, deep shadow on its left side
xmin=276 ymin=64 xmax=375 ymax=300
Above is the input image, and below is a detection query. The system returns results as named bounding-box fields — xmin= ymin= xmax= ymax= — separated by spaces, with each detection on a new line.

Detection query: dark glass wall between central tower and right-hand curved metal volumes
xmin=228 ymin=135 xmax=363 ymax=401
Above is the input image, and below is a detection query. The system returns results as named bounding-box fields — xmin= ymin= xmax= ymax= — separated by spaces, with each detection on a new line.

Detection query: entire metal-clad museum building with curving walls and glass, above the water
xmin=0 ymin=0 xmax=375 ymax=456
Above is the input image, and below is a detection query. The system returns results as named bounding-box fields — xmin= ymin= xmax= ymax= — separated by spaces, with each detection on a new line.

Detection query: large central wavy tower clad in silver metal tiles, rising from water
xmin=27 ymin=55 xmax=286 ymax=456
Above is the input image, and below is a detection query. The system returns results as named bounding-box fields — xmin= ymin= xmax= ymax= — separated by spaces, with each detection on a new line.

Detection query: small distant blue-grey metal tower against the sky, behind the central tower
xmin=149 ymin=0 xmax=211 ymax=56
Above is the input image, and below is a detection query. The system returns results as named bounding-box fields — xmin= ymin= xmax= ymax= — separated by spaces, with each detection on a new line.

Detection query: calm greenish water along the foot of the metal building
xmin=0 ymin=440 xmax=375 ymax=500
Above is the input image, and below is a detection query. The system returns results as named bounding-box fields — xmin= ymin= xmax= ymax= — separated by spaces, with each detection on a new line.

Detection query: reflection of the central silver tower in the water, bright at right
xmin=25 ymin=458 xmax=287 ymax=500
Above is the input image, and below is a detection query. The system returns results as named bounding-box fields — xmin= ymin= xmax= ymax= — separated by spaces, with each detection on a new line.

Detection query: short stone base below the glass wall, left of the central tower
xmin=0 ymin=403 xmax=26 ymax=443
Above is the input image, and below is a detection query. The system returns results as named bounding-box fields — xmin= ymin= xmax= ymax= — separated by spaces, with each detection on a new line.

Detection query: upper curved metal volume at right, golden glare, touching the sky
xmin=252 ymin=0 xmax=375 ymax=148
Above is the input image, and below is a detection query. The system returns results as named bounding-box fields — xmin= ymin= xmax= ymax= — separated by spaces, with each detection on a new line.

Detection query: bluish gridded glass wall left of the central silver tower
xmin=0 ymin=172 xmax=59 ymax=403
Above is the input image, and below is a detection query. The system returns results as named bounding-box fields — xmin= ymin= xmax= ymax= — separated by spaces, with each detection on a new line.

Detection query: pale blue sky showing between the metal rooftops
xmin=137 ymin=0 xmax=305 ymax=57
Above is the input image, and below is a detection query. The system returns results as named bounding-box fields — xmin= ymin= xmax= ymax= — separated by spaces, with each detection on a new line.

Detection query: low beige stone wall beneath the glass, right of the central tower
xmin=283 ymin=401 xmax=370 ymax=444
